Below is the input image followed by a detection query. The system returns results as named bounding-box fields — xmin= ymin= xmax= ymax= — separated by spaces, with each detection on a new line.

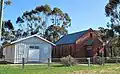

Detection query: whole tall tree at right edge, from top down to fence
xmin=105 ymin=0 xmax=120 ymax=54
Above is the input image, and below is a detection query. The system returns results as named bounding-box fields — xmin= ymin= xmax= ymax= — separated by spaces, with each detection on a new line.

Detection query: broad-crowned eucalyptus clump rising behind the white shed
xmin=16 ymin=5 xmax=71 ymax=42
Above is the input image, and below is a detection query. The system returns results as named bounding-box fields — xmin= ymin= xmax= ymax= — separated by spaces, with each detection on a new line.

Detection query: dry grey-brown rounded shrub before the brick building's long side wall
xmin=60 ymin=55 xmax=77 ymax=66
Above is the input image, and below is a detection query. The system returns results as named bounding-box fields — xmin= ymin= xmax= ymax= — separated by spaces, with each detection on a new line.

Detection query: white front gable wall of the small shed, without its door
xmin=14 ymin=37 xmax=52 ymax=63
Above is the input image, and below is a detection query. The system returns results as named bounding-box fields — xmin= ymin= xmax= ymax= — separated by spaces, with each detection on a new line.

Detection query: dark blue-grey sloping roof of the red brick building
xmin=56 ymin=30 xmax=88 ymax=45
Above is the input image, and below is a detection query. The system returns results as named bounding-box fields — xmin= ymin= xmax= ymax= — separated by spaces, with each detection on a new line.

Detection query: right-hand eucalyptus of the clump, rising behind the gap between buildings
xmin=45 ymin=8 xmax=71 ymax=42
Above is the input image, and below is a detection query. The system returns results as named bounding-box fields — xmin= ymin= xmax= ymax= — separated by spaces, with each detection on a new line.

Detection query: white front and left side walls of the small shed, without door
xmin=3 ymin=37 xmax=52 ymax=63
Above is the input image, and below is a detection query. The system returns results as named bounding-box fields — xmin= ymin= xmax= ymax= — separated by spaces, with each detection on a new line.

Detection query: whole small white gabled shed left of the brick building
xmin=3 ymin=35 xmax=55 ymax=63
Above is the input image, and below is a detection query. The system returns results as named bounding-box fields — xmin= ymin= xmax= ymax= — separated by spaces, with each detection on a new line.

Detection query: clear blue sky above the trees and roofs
xmin=4 ymin=0 xmax=108 ymax=33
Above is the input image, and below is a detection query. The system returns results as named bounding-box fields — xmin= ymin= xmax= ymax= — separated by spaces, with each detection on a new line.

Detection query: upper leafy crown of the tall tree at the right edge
xmin=105 ymin=0 xmax=120 ymax=34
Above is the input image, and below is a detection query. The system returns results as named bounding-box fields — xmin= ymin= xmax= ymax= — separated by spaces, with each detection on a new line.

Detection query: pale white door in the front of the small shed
xmin=28 ymin=49 xmax=40 ymax=62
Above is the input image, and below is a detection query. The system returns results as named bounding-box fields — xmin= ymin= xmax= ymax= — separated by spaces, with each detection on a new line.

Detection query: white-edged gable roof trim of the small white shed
xmin=10 ymin=35 xmax=55 ymax=46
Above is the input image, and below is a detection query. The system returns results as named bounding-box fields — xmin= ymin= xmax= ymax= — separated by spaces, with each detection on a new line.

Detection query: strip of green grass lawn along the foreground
xmin=0 ymin=64 xmax=120 ymax=74
